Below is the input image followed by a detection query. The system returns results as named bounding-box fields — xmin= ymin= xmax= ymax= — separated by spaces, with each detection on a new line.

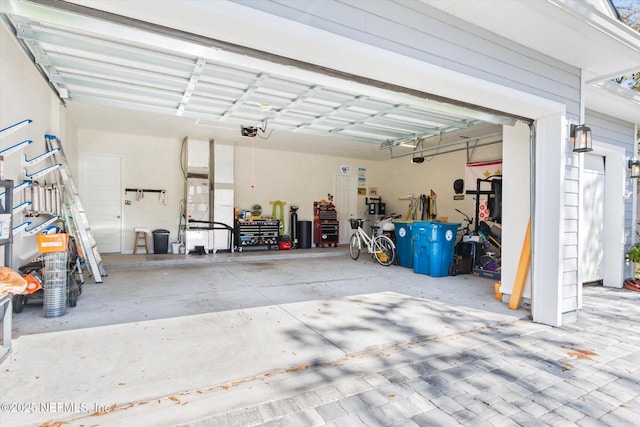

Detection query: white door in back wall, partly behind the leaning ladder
xmin=80 ymin=153 xmax=122 ymax=253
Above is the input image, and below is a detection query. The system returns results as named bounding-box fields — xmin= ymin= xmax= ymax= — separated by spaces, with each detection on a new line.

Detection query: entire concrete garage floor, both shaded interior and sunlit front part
xmin=0 ymin=248 xmax=528 ymax=426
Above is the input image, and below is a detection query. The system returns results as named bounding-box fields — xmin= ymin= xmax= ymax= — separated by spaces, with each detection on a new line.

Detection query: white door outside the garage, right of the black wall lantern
xmin=580 ymin=154 xmax=605 ymax=283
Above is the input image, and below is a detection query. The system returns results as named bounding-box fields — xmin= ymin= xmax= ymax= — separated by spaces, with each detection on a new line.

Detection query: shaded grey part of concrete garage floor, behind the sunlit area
xmin=13 ymin=248 xmax=527 ymax=338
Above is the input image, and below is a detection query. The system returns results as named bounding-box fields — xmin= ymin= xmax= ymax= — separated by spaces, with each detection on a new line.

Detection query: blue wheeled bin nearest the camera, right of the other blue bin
xmin=412 ymin=222 xmax=460 ymax=277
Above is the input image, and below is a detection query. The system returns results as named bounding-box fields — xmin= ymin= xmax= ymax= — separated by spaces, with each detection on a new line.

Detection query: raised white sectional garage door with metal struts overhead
xmin=2 ymin=1 xmax=512 ymax=147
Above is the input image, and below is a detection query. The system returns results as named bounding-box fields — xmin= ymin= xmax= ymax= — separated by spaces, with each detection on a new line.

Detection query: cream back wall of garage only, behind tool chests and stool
xmin=77 ymin=129 xmax=380 ymax=249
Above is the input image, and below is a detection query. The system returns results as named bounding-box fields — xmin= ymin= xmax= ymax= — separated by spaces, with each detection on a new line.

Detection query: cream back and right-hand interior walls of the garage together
xmin=72 ymin=124 xmax=502 ymax=253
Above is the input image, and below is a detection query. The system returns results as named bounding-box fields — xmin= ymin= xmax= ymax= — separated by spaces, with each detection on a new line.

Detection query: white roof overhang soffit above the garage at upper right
xmin=422 ymin=0 xmax=640 ymax=123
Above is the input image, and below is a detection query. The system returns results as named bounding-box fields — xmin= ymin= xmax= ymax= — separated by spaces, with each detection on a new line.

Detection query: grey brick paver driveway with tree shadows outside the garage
xmin=191 ymin=288 xmax=640 ymax=427
